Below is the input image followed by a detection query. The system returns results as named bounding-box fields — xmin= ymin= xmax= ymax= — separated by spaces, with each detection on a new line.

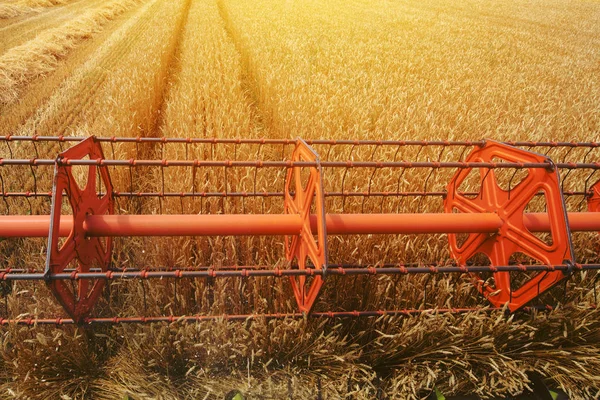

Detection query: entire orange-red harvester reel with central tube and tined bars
xmin=0 ymin=136 xmax=600 ymax=325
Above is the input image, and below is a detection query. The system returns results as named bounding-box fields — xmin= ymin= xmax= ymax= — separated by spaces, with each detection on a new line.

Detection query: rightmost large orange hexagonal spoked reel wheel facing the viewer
xmin=444 ymin=141 xmax=575 ymax=311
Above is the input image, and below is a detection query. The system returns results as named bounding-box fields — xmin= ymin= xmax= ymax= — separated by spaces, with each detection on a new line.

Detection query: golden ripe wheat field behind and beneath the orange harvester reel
xmin=0 ymin=0 xmax=600 ymax=399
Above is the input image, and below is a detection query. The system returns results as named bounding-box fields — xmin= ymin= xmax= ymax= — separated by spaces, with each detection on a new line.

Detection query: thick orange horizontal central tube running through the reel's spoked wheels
xmin=0 ymin=212 xmax=600 ymax=237
